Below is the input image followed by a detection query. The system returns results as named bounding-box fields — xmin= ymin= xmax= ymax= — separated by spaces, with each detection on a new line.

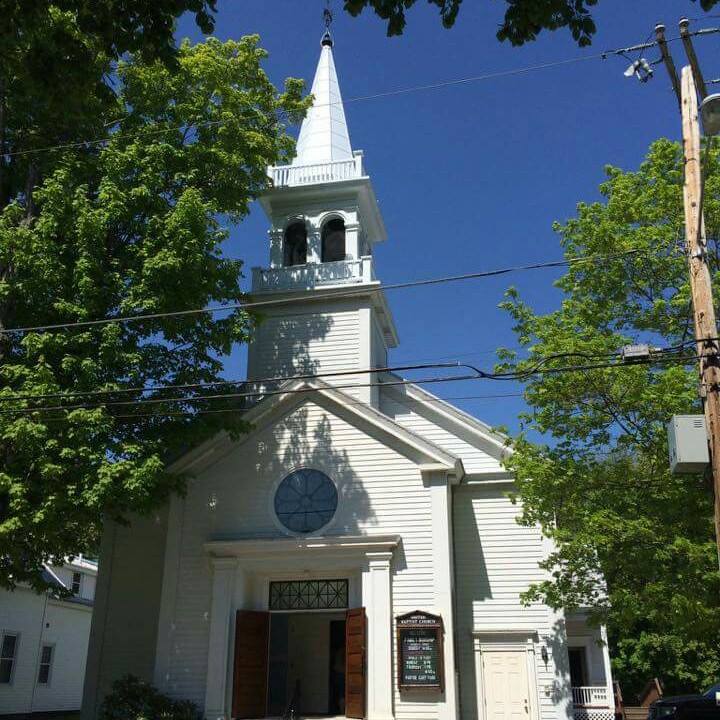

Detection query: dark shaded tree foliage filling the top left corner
xmin=0 ymin=0 xmax=216 ymax=207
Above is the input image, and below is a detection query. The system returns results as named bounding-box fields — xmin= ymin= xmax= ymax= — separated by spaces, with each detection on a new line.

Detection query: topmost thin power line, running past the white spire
xmin=4 ymin=28 xmax=720 ymax=157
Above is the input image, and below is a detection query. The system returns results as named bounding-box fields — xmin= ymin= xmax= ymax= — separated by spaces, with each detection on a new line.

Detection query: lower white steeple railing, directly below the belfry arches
xmin=252 ymin=255 xmax=375 ymax=292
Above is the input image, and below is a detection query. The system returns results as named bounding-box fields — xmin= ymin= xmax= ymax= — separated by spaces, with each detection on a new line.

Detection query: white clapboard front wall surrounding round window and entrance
xmin=160 ymin=401 xmax=437 ymax=720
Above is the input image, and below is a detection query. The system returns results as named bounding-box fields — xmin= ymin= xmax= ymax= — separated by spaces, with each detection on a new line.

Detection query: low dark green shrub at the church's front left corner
xmin=99 ymin=675 xmax=201 ymax=720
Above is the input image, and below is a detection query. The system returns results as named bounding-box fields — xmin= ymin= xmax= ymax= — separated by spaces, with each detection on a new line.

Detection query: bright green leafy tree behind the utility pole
xmin=504 ymin=140 xmax=720 ymax=695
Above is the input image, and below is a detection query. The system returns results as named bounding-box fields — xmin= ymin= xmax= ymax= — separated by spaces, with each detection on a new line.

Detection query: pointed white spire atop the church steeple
xmin=293 ymin=29 xmax=353 ymax=165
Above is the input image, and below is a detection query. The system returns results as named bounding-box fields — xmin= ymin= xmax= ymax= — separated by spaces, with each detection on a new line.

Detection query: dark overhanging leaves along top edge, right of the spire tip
xmin=345 ymin=0 xmax=718 ymax=47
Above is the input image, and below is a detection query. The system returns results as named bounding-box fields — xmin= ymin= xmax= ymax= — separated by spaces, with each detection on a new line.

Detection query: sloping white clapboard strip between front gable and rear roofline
xmin=380 ymin=391 xmax=503 ymax=473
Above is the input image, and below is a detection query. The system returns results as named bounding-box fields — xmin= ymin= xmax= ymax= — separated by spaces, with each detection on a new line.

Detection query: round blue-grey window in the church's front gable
xmin=274 ymin=469 xmax=338 ymax=533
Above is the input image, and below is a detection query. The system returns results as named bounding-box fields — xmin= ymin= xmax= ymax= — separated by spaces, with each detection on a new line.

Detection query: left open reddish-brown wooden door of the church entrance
xmin=232 ymin=610 xmax=270 ymax=718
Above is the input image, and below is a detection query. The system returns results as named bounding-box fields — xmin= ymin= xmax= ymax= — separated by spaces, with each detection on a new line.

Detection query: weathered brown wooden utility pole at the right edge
xmin=680 ymin=65 xmax=720 ymax=560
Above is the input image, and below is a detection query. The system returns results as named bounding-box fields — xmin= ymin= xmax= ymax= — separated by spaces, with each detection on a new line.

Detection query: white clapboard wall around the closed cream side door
xmin=454 ymin=484 xmax=558 ymax=720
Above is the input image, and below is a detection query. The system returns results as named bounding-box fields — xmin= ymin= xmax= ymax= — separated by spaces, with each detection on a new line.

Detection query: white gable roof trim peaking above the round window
xmin=169 ymin=379 xmax=465 ymax=482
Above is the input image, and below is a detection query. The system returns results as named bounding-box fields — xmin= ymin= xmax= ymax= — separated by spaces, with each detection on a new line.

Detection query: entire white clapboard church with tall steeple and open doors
xmin=83 ymin=28 xmax=614 ymax=720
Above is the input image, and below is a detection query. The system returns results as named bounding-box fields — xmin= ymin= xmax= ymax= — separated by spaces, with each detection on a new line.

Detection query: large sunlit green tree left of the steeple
xmin=0 ymin=37 xmax=307 ymax=586
